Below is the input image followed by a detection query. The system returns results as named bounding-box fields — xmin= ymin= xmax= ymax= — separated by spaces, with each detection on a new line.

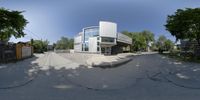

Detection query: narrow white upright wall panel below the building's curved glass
xmin=89 ymin=37 xmax=97 ymax=53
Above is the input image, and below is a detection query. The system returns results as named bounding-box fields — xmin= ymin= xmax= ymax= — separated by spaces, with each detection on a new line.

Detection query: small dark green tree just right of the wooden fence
xmin=32 ymin=40 xmax=49 ymax=53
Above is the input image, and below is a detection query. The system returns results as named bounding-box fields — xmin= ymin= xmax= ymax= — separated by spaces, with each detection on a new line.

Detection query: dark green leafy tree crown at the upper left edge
xmin=0 ymin=8 xmax=28 ymax=42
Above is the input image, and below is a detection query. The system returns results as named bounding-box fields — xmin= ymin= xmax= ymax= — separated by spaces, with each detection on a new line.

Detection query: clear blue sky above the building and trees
xmin=0 ymin=0 xmax=200 ymax=43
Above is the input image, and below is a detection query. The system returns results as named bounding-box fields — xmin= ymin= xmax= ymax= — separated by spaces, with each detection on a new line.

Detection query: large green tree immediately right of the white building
xmin=122 ymin=30 xmax=154 ymax=51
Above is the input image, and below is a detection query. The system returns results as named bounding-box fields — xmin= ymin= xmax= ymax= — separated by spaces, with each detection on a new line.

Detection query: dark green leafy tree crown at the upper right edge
xmin=165 ymin=8 xmax=200 ymax=45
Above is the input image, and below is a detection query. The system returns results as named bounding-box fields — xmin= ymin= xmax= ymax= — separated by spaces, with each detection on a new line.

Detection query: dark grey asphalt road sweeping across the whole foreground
xmin=0 ymin=54 xmax=200 ymax=100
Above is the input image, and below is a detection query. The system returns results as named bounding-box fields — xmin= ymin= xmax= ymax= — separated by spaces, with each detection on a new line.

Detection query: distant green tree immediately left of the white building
xmin=55 ymin=37 xmax=74 ymax=49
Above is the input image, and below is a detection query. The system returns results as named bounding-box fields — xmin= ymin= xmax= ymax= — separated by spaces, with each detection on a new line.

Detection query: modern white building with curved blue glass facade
xmin=74 ymin=21 xmax=132 ymax=54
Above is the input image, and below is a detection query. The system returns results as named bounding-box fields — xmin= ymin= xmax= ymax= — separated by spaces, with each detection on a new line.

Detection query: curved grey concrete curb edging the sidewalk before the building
xmin=92 ymin=56 xmax=132 ymax=68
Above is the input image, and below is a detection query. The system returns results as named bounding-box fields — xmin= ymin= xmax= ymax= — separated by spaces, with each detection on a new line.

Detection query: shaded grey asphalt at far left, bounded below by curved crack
xmin=0 ymin=56 xmax=38 ymax=89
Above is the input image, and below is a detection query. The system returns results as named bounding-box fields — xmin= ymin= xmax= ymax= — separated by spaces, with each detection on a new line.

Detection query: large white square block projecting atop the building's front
xmin=99 ymin=21 xmax=117 ymax=38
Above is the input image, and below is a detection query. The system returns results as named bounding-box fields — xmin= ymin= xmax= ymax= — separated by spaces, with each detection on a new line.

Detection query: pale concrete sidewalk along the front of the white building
xmin=57 ymin=52 xmax=157 ymax=68
